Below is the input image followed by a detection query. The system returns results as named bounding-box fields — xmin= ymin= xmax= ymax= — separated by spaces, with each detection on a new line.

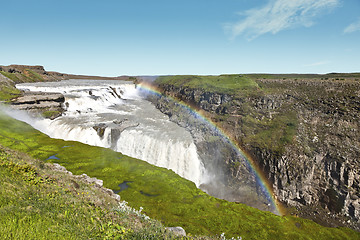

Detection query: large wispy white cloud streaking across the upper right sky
xmin=225 ymin=0 xmax=340 ymax=40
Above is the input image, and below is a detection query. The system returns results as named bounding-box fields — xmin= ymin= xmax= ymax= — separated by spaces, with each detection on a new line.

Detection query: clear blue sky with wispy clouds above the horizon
xmin=0 ymin=0 xmax=360 ymax=76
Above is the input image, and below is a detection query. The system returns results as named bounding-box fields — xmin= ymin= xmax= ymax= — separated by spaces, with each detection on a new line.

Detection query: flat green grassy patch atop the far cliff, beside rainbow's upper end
xmin=156 ymin=75 xmax=259 ymax=95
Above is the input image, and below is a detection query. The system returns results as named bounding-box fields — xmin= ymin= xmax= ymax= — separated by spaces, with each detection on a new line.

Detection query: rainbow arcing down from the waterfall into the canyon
xmin=136 ymin=82 xmax=285 ymax=215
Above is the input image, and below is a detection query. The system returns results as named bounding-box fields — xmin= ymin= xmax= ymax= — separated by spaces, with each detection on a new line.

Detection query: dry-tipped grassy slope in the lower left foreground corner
xmin=0 ymin=146 xmax=186 ymax=239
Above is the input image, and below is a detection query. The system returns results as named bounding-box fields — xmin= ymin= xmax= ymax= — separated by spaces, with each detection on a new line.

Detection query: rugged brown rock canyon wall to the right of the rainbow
xmin=153 ymin=77 xmax=360 ymax=230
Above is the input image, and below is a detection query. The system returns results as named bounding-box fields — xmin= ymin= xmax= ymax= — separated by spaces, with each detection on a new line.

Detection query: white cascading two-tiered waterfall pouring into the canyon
xmin=17 ymin=80 xmax=206 ymax=186
